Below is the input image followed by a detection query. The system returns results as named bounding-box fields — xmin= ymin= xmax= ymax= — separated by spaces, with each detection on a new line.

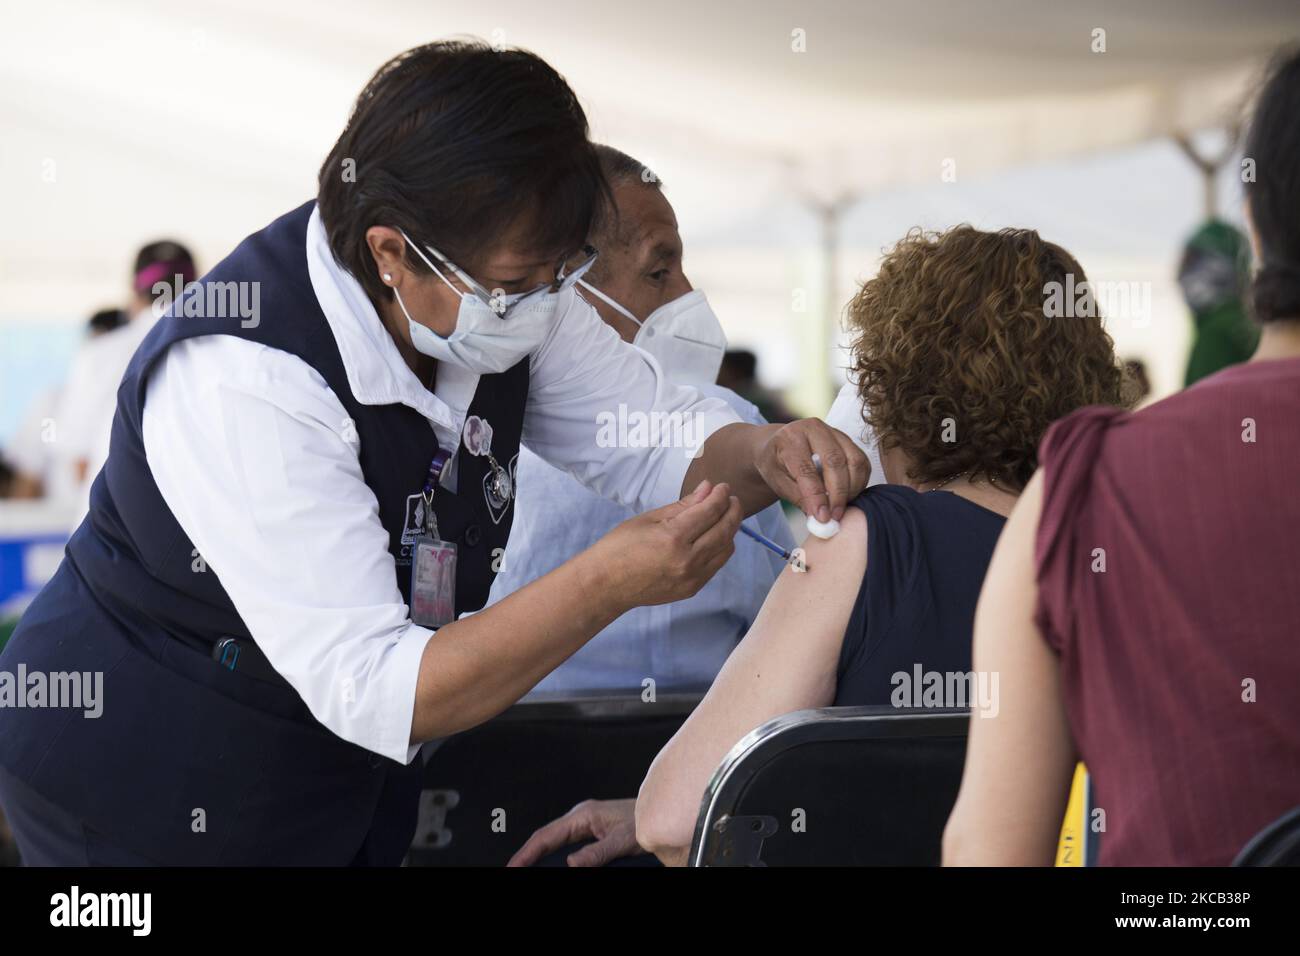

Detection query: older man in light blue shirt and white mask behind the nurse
xmin=488 ymin=146 xmax=794 ymax=692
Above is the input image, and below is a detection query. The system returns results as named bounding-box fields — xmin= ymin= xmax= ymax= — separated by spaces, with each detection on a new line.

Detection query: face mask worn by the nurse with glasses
xmin=393 ymin=230 xmax=559 ymax=375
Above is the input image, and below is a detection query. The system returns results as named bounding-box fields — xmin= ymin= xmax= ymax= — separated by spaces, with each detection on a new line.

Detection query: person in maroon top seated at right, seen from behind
xmin=944 ymin=46 xmax=1300 ymax=866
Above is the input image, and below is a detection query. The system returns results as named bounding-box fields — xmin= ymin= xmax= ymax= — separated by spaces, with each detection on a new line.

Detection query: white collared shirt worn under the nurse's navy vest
xmin=143 ymin=212 xmax=740 ymax=762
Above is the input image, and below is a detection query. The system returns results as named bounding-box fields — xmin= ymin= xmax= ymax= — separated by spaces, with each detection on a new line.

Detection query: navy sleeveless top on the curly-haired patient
xmin=835 ymin=485 xmax=1006 ymax=706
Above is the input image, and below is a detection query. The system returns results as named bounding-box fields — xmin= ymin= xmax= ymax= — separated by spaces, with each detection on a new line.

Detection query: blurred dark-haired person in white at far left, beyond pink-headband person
xmin=0 ymin=308 xmax=127 ymax=501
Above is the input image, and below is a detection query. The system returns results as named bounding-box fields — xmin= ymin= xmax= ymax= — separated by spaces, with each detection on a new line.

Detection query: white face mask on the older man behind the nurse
xmin=579 ymin=280 xmax=727 ymax=385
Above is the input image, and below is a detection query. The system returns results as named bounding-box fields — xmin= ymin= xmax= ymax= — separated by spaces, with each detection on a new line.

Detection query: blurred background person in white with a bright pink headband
xmin=52 ymin=239 xmax=199 ymax=528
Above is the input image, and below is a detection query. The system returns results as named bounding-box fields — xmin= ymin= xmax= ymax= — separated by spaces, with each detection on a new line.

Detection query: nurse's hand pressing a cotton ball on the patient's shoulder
xmin=754 ymin=419 xmax=871 ymax=522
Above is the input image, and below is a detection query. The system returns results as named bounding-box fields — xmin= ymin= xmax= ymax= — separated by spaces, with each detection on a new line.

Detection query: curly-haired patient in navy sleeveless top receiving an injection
xmin=636 ymin=226 xmax=1122 ymax=864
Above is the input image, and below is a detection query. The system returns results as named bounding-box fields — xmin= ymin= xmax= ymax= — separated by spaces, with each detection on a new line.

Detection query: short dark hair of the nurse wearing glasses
xmin=317 ymin=40 xmax=608 ymax=302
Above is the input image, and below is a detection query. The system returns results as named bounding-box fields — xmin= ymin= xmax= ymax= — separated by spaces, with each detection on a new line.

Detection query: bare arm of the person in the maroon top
xmin=944 ymin=472 xmax=1075 ymax=866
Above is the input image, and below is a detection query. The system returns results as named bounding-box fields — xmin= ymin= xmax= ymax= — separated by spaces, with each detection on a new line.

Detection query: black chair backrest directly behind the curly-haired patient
xmin=690 ymin=706 xmax=970 ymax=866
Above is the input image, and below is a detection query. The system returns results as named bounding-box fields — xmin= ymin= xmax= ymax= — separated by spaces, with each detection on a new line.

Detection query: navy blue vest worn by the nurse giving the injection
xmin=0 ymin=203 xmax=528 ymax=865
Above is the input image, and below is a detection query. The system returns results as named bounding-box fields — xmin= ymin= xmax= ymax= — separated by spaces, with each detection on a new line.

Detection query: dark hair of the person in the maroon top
xmin=1245 ymin=48 xmax=1300 ymax=323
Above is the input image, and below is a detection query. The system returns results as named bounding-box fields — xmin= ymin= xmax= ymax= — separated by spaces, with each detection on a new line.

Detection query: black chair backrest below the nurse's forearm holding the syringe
xmin=407 ymin=693 xmax=702 ymax=866
